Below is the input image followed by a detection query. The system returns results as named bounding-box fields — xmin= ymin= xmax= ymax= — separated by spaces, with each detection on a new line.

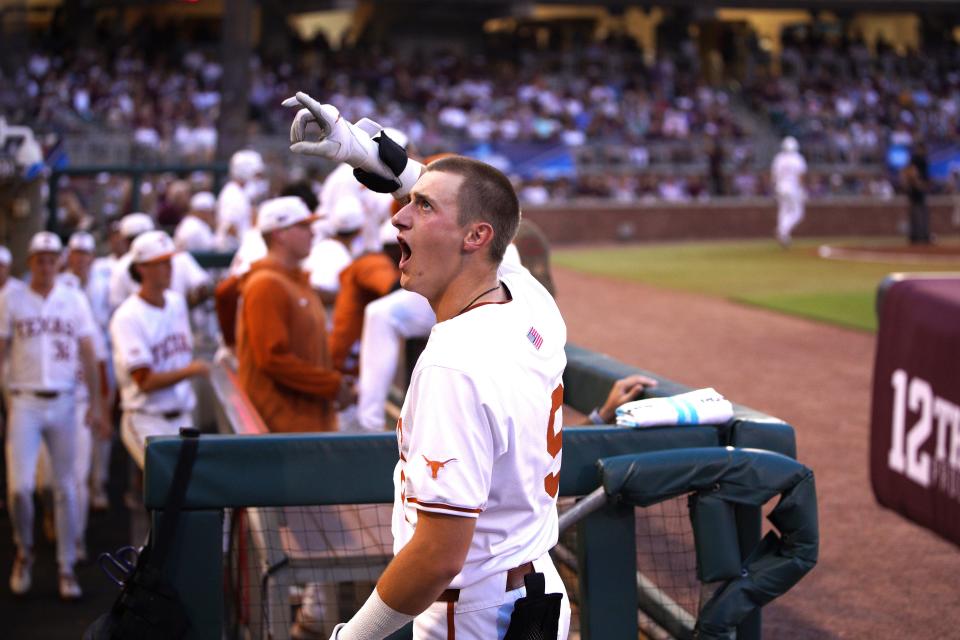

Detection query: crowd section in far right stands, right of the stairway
xmin=745 ymin=32 xmax=960 ymax=165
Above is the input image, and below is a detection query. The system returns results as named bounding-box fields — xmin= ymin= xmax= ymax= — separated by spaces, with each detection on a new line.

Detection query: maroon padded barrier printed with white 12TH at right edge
xmin=870 ymin=274 xmax=960 ymax=545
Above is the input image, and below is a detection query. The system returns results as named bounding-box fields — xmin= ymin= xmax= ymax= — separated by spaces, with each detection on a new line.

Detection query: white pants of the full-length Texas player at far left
xmin=6 ymin=392 xmax=78 ymax=572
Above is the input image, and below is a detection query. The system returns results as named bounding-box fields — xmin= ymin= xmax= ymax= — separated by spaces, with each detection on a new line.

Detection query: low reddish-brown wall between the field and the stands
xmin=523 ymin=197 xmax=960 ymax=245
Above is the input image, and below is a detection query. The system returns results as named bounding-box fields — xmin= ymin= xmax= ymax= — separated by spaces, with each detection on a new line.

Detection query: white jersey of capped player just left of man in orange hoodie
xmin=110 ymin=290 xmax=196 ymax=414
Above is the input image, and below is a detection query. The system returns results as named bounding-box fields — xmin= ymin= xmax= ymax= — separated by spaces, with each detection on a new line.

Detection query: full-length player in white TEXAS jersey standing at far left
xmin=0 ymin=231 xmax=107 ymax=600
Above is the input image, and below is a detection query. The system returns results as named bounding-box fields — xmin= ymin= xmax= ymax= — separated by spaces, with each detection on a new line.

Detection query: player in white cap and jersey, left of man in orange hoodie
xmin=110 ymin=231 xmax=209 ymax=469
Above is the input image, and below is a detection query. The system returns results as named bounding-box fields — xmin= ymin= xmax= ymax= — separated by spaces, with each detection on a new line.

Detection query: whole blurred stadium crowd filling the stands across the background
xmin=0 ymin=15 xmax=960 ymax=203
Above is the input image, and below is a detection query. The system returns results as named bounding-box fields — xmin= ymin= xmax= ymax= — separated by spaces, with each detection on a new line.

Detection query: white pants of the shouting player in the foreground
xmin=413 ymin=554 xmax=570 ymax=640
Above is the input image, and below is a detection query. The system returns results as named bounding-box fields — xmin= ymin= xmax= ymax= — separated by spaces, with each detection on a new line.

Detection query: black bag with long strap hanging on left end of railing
xmin=83 ymin=428 xmax=200 ymax=640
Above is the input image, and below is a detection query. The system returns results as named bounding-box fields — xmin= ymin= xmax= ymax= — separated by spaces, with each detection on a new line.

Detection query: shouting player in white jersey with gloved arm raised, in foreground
xmin=284 ymin=93 xmax=570 ymax=640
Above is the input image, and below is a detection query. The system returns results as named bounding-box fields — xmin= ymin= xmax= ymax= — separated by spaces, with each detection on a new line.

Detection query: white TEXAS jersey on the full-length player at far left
xmin=0 ymin=282 xmax=96 ymax=391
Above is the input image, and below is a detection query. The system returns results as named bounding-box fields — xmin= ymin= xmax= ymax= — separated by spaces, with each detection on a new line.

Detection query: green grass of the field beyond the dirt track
xmin=551 ymin=238 xmax=960 ymax=331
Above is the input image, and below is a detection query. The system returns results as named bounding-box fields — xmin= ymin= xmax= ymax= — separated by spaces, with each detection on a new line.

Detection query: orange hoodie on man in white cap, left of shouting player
xmin=237 ymin=257 xmax=340 ymax=432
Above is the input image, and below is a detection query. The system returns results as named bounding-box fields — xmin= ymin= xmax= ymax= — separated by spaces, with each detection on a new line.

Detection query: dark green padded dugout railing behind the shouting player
xmin=144 ymin=346 xmax=796 ymax=640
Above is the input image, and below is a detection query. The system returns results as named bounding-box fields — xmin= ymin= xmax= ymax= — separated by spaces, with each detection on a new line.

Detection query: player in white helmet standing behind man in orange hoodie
xmin=216 ymin=149 xmax=269 ymax=251
